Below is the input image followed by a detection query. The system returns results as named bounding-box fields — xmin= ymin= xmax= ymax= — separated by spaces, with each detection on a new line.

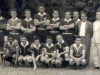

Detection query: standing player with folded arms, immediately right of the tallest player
xmin=47 ymin=9 xmax=62 ymax=44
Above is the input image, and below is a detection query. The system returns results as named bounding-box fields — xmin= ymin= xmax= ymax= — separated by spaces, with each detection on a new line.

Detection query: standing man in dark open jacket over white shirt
xmin=78 ymin=11 xmax=93 ymax=66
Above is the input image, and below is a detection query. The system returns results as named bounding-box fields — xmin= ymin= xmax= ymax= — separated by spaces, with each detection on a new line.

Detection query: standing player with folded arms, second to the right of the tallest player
xmin=60 ymin=11 xmax=74 ymax=45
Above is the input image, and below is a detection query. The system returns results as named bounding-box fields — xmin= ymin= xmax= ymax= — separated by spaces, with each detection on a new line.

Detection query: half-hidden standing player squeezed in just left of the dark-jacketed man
xmin=73 ymin=11 xmax=81 ymax=35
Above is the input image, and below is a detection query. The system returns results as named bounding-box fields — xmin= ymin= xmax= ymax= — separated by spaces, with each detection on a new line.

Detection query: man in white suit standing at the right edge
xmin=92 ymin=10 xmax=100 ymax=69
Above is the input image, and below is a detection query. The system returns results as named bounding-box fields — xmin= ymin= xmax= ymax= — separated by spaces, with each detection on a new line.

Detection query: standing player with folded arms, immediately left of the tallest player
xmin=21 ymin=9 xmax=36 ymax=43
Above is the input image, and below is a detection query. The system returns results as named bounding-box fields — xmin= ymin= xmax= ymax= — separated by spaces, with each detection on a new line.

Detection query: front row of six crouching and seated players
xmin=3 ymin=34 xmax=86 ymax=69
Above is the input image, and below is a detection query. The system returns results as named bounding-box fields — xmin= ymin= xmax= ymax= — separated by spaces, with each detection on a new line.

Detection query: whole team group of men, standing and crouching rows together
xmin=0 ymin=4 xmax=100 ymax=69
